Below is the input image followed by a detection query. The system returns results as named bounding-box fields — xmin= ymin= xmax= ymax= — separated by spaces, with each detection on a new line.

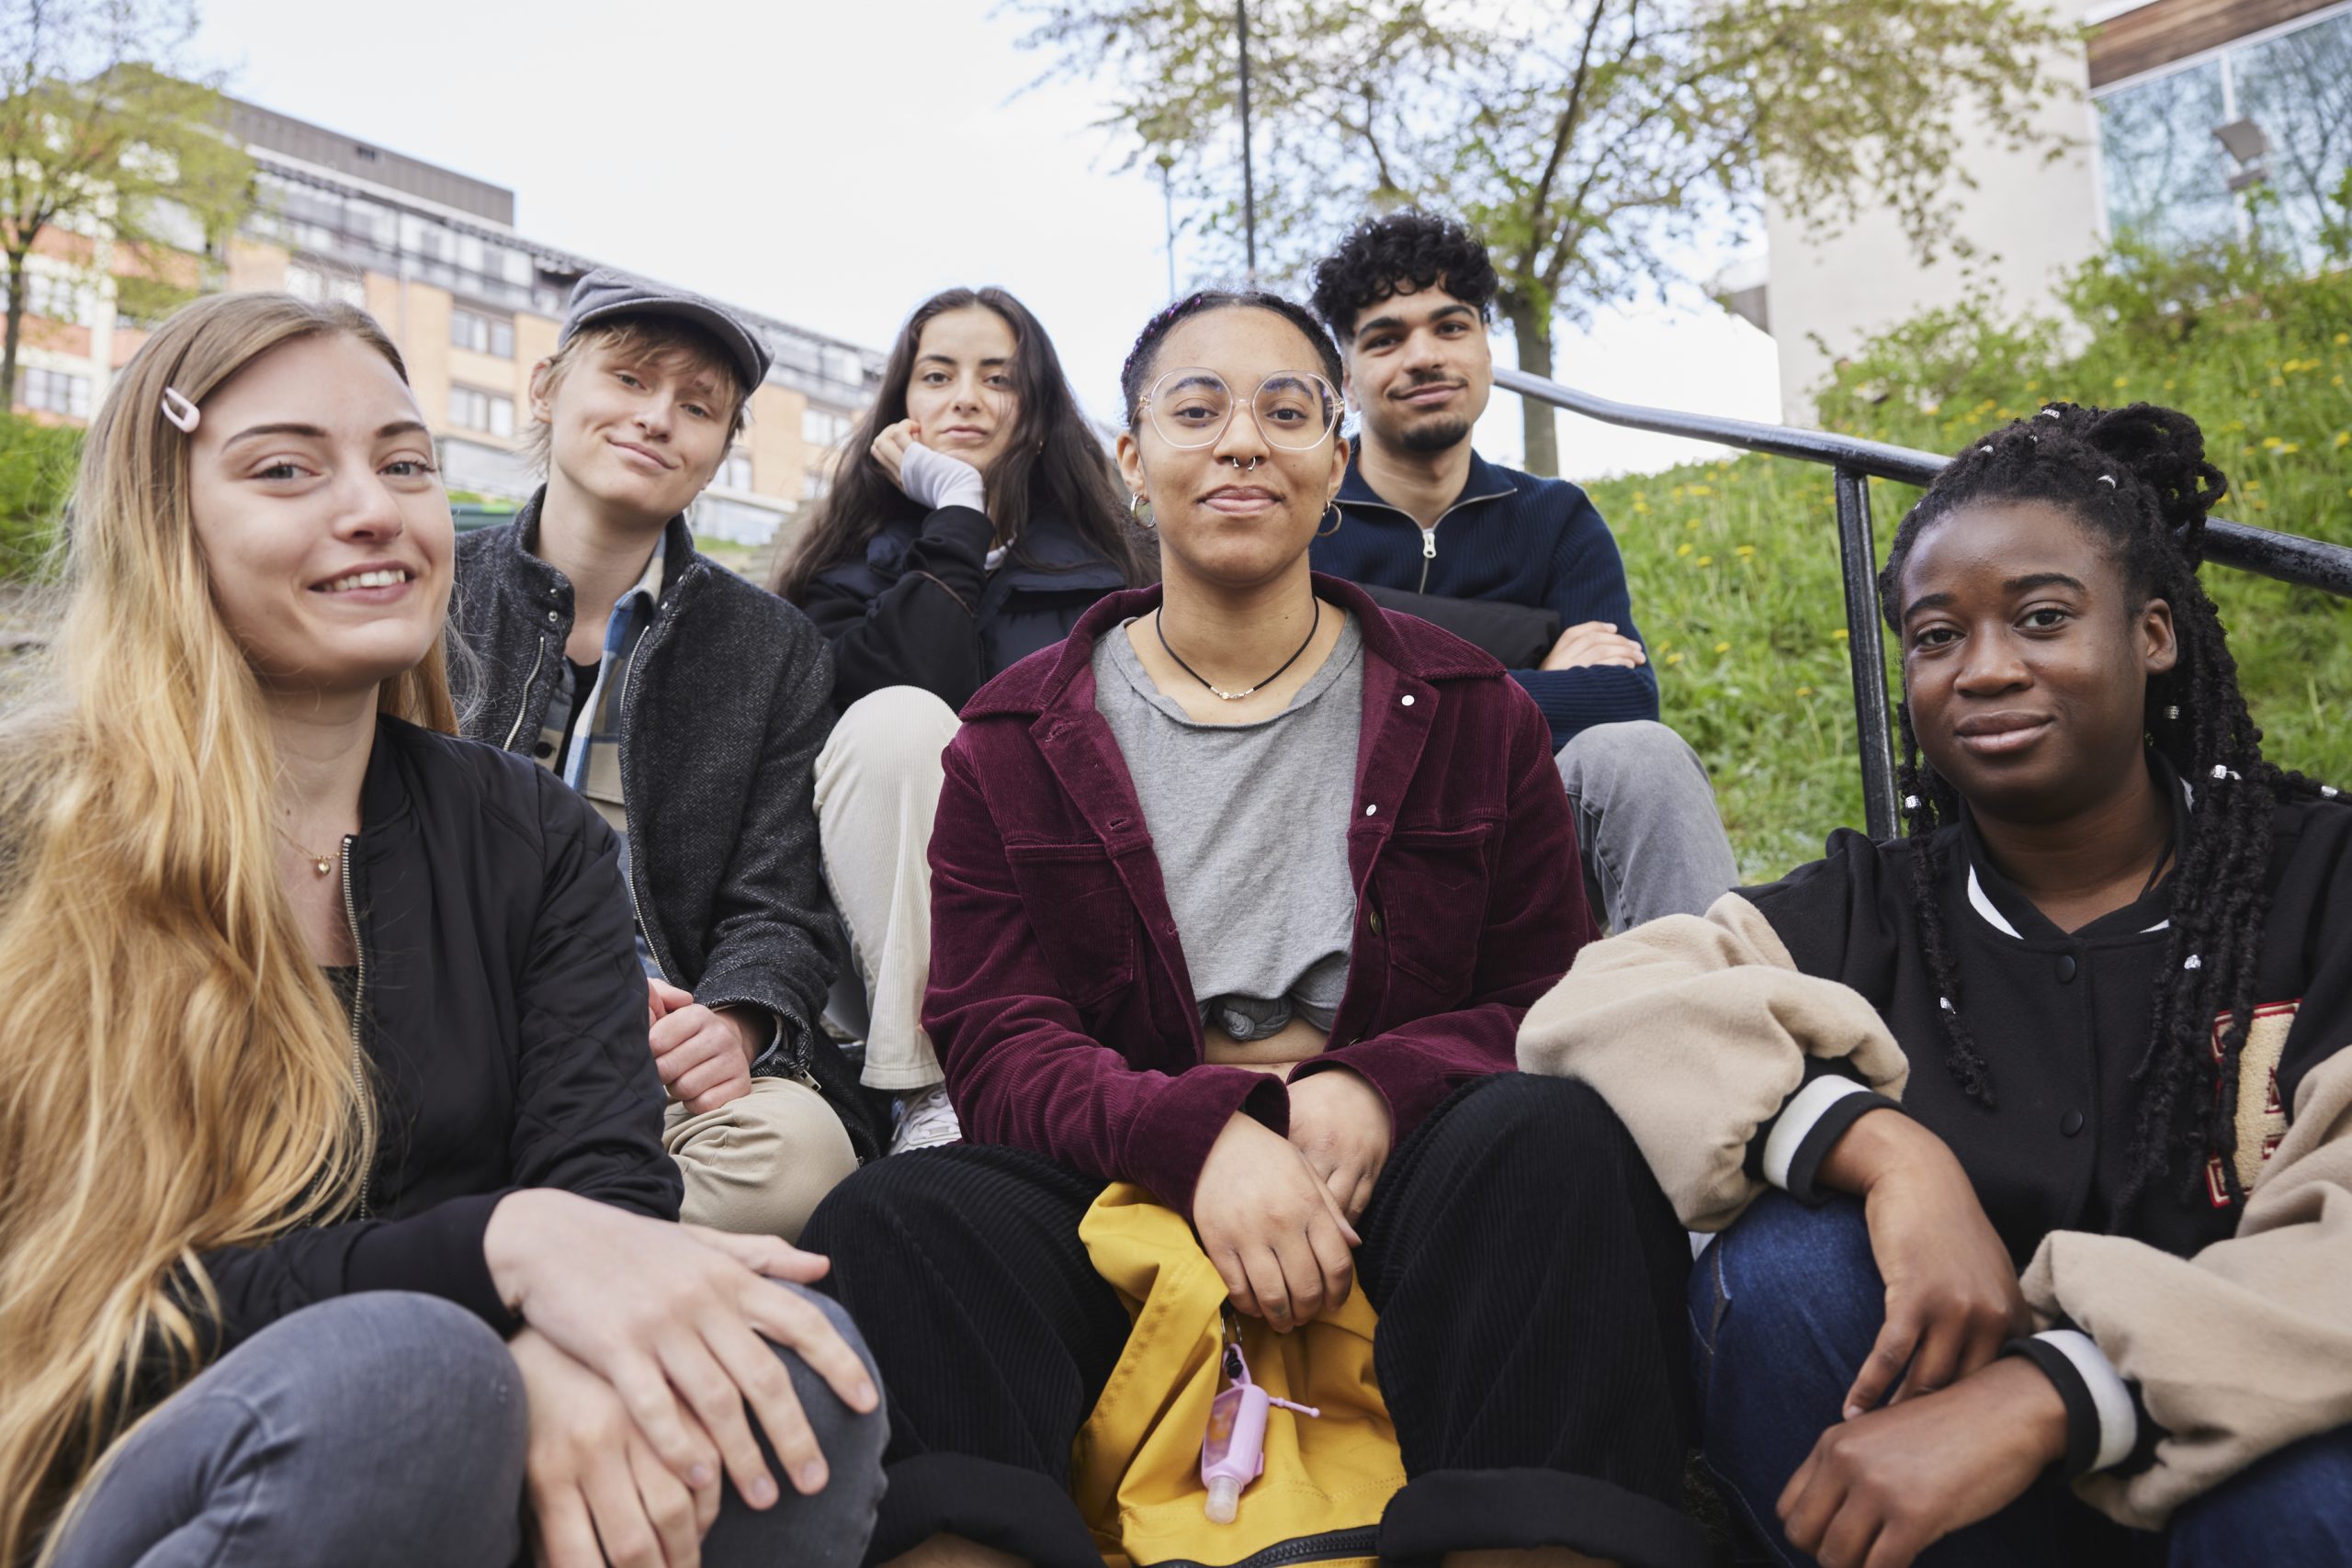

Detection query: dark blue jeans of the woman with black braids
xmin=1691 ymin=1192 xmax=2352 ymax=1568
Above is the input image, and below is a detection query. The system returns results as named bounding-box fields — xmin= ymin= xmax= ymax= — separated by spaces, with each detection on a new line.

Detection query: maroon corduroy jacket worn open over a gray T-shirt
xmin=922 ymin=573 xmax=1595 ymax=1213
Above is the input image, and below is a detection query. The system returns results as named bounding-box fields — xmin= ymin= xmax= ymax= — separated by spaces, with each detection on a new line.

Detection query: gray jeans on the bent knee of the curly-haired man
xmin=1555 ymin=719 xmax=1740 ymax=931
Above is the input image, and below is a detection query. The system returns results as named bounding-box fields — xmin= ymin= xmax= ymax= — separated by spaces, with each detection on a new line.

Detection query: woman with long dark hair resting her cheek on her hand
xmin=776 ymin=289 xmax=1158 ymax=1149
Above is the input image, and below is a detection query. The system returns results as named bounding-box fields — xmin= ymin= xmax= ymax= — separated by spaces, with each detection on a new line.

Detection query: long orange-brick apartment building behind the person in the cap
xmin=17 ymin=101 xmax=882 ymax=547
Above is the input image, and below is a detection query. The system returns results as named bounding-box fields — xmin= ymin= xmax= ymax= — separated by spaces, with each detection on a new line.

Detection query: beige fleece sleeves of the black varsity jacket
xmin=1520 ymin=894 xmax=2352 ymax=1530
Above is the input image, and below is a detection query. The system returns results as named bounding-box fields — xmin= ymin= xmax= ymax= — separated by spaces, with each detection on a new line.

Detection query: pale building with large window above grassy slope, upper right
xmin=1758 ymin=0 xmax=2352 ymax=421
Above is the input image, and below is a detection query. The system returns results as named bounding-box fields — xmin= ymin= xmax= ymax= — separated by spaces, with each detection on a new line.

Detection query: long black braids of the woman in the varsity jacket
xmin=1879 ymin=402 xmax=2334 ymax=1223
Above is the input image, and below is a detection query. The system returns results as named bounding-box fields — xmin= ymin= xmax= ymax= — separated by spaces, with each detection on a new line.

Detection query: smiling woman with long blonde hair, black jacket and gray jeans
xmin=0 ymin=294 xmax=882 ymax=1568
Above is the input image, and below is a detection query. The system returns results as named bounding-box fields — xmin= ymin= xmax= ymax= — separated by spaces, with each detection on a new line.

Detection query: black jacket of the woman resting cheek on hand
xmin=802 ymin=505 xmax=1129 ymax=707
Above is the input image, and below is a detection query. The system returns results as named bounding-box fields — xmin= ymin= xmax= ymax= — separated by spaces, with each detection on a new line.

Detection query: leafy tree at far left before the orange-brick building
xmin=0 ymin=0 xmax=254 ymax=404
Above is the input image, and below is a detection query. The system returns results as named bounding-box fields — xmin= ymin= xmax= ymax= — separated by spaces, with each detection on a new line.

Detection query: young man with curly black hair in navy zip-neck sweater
xmin=1315 ymin=211 xmax=1738 ymax=929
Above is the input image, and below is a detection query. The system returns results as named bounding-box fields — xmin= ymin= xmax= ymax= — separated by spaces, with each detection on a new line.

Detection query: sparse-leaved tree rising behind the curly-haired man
xmin=1009 ymin=0 xmax=2079 ymax=472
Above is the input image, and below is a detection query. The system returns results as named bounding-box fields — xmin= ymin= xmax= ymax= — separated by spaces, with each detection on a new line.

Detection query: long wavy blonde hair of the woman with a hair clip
xmin=0 ymin=294 xmax=454 ymax=1565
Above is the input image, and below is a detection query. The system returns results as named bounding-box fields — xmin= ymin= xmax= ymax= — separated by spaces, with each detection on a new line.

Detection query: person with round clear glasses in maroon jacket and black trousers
xmin=805 ymin=294 xmax=1708 ymax=1568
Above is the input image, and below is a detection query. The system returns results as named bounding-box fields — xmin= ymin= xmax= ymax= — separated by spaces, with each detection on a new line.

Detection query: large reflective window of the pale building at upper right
xmin=2098 ymin=7 xmax=2352 ymax=265
